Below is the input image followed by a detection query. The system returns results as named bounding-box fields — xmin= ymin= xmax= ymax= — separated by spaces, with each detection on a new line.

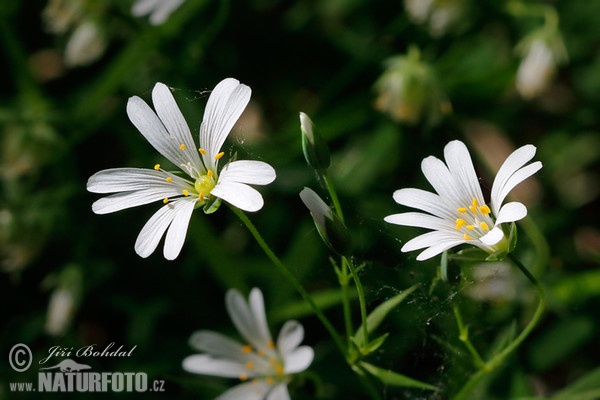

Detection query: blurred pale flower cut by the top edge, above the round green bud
xmin=404 ymin=0 xmax=465 ymax=37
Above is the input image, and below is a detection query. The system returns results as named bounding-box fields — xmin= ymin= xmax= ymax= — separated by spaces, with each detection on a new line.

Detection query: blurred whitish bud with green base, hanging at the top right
xmin=516 ymin=26 xmax=568 ymax=99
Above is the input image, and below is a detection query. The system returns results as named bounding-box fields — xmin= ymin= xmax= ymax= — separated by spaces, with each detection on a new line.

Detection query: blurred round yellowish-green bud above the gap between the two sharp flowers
xmin=375 ymin=48 xmax=452 ymax=125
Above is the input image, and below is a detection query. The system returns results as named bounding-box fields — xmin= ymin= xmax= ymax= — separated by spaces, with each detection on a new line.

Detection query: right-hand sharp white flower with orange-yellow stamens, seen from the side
xmin=385 ymin=140 xmax=542 ymax=260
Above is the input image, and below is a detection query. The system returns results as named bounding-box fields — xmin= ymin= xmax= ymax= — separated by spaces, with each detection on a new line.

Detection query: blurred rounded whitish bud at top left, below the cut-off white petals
xmin=64 ymin=21 xmax=106 ymax=67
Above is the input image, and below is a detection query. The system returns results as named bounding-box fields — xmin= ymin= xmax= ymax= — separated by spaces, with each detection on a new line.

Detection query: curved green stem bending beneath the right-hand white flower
xmin=454 ymin=254 xmax=546 ymax=400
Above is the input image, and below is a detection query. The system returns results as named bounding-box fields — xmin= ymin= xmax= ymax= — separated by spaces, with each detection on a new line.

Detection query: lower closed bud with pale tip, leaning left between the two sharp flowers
xmin=300 ymin=187 xmax=352 ymax=255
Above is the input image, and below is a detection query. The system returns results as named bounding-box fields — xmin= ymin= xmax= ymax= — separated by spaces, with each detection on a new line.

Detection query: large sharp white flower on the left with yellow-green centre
xmin=87 ymin=78 xmax=275 ymax=260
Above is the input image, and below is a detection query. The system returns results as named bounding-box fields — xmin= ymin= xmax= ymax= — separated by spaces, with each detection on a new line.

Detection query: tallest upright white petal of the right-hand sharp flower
xmin=444 ymin=140 xmax=485 ymax=204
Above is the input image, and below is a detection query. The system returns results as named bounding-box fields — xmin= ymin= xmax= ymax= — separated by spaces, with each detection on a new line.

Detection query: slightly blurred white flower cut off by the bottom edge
xmin=183 ymin=288 xmax=314 ymax=400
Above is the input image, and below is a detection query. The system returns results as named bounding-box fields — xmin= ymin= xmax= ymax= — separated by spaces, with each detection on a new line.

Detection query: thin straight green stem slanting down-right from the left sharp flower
xmin=230 ymin=206 xmax=347 ymax=357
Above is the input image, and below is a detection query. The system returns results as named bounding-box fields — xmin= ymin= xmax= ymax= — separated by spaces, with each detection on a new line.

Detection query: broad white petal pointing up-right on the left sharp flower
xmin=200 ymin=78 xmax=252 ymax=170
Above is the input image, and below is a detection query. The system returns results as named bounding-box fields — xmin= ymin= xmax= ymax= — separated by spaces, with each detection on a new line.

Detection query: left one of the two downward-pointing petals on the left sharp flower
xmin=135 ymin=198 xmax=190 ymax=258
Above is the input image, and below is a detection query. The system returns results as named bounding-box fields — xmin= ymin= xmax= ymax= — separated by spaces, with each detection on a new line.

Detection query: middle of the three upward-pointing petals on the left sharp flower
xmin=152 ymin=82 xmax=201 ymax=166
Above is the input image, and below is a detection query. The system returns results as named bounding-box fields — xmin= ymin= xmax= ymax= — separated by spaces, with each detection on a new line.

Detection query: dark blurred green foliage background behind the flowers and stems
xmin=0 ymin=0 xmax=600 ymax=399
